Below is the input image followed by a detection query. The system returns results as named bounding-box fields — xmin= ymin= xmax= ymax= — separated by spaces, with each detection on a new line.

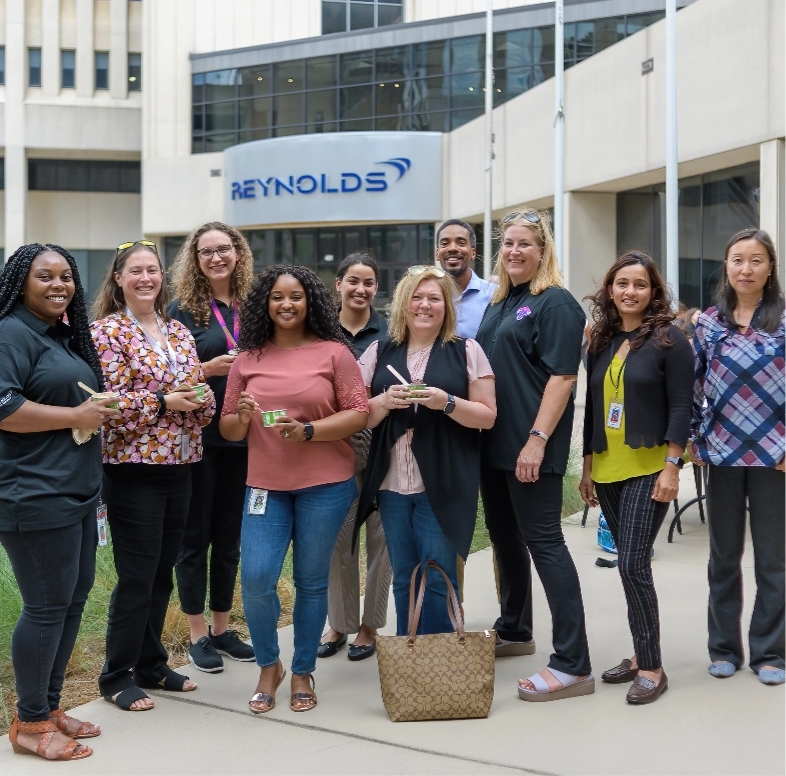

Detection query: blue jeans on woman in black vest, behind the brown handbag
xmin=377 ymin=490 xmax=458 ymax=636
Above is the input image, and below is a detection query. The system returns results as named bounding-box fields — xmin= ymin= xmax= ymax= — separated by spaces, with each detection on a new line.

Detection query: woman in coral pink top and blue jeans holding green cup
xmin=220 ymin=265 xmax=368 ymax=714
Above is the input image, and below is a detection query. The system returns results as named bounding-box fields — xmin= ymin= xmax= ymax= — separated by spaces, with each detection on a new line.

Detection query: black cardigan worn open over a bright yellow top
xmin=584 ymin=326 xmax=693 ymax=455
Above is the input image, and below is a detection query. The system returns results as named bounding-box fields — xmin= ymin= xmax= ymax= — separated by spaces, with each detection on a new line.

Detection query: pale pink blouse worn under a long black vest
xmin=358 ymin=339 xmax=494 ymax=496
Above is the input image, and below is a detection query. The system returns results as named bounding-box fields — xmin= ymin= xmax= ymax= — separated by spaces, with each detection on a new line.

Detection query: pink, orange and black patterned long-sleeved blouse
xmin=90 ymin=313 xmax=216 ymax=464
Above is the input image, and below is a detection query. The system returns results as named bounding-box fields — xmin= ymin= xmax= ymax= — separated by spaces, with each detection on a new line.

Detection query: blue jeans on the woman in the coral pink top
xmin=240 ymin=477 xmax=357 ymax=676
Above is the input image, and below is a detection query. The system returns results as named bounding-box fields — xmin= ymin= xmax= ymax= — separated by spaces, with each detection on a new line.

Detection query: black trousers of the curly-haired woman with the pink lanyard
xmin=175 ymin=447 xmax=248 ymax=614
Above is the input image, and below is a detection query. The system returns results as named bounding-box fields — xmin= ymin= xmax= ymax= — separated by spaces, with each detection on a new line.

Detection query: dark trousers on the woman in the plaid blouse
xmin=707 ymin=466 xmax=786 ymax=671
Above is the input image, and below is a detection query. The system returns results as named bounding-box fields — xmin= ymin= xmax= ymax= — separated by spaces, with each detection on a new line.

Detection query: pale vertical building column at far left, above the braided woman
xmin=4 ymin=0 xmax=27 ymax=261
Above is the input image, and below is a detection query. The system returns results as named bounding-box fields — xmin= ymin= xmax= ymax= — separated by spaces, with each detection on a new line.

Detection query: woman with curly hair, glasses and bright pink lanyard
xmin=169 ymin=221 xmax=254 ymax=673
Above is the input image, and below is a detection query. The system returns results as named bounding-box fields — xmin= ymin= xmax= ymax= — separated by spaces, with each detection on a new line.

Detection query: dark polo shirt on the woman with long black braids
xmin=0 ymin=303 xmax=101 ymax=531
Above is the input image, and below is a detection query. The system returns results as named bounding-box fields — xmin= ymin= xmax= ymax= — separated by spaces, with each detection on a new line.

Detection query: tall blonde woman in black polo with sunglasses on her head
xmin=478 ymin=209 xmax=595 ymax=701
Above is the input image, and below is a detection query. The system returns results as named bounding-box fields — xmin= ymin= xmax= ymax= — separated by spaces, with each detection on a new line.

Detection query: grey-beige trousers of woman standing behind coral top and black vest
xmin=328 ymin=431 xmax=393 ymax=633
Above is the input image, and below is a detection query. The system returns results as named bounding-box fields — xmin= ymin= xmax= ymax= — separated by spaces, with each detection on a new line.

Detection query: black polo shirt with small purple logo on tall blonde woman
xmin=477 ymin=283 xmax=586 ymax=474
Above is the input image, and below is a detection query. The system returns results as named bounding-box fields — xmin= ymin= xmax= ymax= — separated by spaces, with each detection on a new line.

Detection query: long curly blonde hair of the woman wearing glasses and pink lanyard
xmin=170 ymin=221 xmax=254 ymax=328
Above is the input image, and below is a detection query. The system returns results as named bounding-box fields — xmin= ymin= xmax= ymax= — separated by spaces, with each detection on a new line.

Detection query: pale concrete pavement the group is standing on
xmin=0 ymin=467 xmax=786 ymax=776
